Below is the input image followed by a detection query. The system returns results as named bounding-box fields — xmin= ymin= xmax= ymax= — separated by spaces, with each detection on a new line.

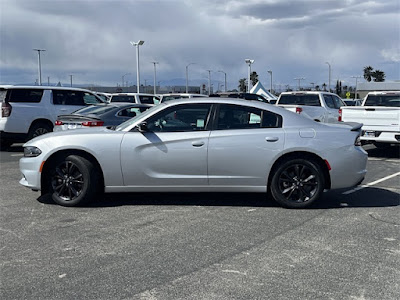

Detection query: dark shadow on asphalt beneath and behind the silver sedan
xmin=37 ymin=188 xmax=400 ymax=210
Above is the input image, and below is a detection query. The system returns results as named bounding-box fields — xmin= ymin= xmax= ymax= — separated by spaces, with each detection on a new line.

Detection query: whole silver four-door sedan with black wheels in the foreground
xmin=20 ymin=98 xmax=367 ymax=208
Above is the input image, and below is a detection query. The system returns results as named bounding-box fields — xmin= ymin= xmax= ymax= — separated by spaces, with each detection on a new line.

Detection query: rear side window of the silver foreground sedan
xmin=217 ymin=104 xmax=282 ymax=130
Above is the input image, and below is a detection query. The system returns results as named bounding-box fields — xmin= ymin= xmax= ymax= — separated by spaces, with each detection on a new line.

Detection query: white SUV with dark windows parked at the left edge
xmin=0 ymin=85 xmax=104 ymax=149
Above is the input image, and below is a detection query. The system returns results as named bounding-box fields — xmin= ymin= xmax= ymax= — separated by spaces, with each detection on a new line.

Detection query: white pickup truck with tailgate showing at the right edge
xmin=341 ymin=91 xmax=400 ymax=147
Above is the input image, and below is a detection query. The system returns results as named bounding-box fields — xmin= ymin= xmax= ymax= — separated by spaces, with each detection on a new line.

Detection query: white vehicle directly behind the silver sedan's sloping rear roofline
xmin=275 ymin=91 xmax=346 ymax=123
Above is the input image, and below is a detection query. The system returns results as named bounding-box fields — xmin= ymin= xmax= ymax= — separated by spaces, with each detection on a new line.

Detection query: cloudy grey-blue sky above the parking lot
xmin=0 ymin=0 xmax=400 ymax=89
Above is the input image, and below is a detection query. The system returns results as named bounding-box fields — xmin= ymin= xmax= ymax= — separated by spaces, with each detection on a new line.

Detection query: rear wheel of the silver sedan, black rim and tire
xmin=270 ymin=158 xmax=325 ymax=208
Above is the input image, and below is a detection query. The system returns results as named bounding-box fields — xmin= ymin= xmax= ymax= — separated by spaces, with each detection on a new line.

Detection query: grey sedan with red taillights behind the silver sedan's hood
xmin=54 ymin=102 xmax=152 ymax=131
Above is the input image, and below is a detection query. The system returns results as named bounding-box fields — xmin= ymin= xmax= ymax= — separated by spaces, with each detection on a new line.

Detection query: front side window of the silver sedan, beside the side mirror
xmin=146 ymin=104 xmax=211 ymax=132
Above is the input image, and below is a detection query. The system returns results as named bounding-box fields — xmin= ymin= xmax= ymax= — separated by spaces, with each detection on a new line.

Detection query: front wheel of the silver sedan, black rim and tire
xmin=47 ymin=155 xmax=99 ymax=206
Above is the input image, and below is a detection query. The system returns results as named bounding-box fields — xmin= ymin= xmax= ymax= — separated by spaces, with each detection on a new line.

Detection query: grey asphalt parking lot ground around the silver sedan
xmin=0 ymin=145 xmax=400 ymax=300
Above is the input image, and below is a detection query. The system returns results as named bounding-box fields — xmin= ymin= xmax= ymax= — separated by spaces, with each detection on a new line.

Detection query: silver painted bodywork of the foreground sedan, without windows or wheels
xmin=20 ymin=98 xmax=367 ymax=192
